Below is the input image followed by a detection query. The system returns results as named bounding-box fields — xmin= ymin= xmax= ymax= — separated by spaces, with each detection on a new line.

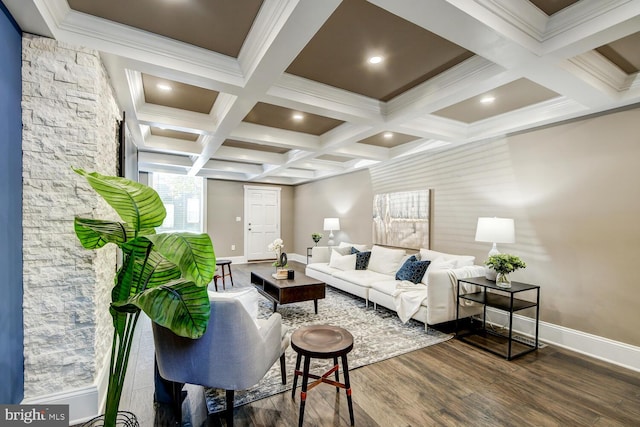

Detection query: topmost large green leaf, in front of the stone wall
xmin=74 ymin=169 xmax=167 ymax=231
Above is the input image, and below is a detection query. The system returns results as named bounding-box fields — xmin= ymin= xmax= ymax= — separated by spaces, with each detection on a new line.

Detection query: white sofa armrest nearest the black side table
xmin=427 ymin=265 xmax=484 ymax=325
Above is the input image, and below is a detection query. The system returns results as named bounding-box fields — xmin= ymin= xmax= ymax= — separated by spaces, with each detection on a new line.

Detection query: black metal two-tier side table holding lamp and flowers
xmin=456 ymin=277 xmax=540 ymax=360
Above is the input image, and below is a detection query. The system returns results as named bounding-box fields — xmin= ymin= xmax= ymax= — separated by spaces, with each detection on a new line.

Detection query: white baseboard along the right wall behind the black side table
xmin=487 ymin=307 xmax=640 ymax=372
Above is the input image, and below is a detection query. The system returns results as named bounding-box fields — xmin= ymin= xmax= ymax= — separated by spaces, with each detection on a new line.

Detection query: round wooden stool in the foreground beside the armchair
xmin=291 ymin=325 xmax=354 ymax=427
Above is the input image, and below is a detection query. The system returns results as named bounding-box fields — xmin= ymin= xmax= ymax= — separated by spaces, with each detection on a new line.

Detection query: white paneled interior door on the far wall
xmin=244 ymin=185 xmax=281 ymax=261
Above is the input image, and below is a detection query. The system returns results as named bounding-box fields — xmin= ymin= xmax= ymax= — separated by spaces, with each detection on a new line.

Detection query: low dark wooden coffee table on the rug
xmin=251 ymin=268 xmax=327 ymax=314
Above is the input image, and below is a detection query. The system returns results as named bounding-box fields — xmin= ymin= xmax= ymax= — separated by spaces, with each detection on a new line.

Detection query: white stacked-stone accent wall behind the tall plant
xmin=22 ymin=34 xmax=120 ymax=398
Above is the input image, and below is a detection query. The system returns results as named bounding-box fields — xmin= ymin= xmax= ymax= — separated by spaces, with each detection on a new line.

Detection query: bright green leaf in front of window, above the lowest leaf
xmin=147 ymin=233 xmax=216 ymax=286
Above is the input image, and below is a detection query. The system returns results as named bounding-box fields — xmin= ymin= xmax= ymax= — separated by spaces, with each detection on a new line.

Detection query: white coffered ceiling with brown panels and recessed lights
xmin=2 ymin=0 xmax=640 ymax=184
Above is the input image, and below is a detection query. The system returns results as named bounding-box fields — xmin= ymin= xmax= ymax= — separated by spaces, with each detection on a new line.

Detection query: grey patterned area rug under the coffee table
xmin=205 ymin=287 xmax=452 ymax=414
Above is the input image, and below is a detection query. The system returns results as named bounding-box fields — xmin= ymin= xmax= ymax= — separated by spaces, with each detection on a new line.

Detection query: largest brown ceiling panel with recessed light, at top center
xmin=287 ymin=0 xmax=473 ymax=101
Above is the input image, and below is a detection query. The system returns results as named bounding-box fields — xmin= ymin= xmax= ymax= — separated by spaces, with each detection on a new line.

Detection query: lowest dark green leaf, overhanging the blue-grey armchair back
xmin=113 ymin=279 xmax=211 ymax=339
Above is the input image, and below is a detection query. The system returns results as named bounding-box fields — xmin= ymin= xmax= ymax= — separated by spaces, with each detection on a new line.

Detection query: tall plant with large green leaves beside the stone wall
xmin=74 ymin=169 xmax=216 ymax=426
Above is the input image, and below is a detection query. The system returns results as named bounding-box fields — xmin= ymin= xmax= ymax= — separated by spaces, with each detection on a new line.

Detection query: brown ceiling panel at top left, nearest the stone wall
xmin=68 ymin=0 xmax=262 ymax=58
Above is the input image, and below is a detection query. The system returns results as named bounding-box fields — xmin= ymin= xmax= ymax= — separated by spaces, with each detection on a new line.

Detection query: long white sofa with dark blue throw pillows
xmin=305 ymin=243 xmax=484 ymax=327
